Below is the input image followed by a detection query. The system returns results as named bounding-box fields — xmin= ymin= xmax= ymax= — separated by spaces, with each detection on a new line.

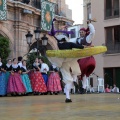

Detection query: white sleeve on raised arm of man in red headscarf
xmin=86 ymin=23 xmax=95 ymax=43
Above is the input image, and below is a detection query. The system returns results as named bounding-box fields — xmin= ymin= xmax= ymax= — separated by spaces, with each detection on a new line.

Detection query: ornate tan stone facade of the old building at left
xmin=0 ymin=0 xmax=74 ymax=58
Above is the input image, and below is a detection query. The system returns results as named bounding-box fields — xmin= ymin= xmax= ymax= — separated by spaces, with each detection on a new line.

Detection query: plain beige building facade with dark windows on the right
xmin=83 ymin=0 xmax=120 ymax=88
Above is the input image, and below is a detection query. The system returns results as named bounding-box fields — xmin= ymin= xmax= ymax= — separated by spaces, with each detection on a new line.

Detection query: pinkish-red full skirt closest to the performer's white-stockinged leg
xmin=47 ymin=72 xmax=62 ymax=92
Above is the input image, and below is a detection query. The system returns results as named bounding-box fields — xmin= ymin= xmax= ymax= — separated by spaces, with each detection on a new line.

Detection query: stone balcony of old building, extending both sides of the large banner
xmin=7 ymin=0 xmax=74 ymax=24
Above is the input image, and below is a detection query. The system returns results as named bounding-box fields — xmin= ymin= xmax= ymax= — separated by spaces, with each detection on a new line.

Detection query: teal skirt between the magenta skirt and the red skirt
xmin=21 ymin=74 xmax=32 ymax=93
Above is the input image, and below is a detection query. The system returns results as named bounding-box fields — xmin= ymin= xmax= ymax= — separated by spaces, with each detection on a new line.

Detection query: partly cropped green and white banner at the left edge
xmin=0 ymin=0 xmax=7 ymax=21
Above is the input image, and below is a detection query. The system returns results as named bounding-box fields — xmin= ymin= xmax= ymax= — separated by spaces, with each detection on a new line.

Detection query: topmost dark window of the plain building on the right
xmin=105 ymin=0 xmax=120 ymax=19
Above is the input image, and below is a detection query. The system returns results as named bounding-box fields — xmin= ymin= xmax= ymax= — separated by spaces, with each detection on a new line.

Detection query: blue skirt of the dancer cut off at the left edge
xmin=0 ymin=72 xmax=7 ymax=95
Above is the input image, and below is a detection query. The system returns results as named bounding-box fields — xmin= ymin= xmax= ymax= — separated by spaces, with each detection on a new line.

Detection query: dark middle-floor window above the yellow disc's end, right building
xmin=105 ymin=25 xmax=120 ymax=53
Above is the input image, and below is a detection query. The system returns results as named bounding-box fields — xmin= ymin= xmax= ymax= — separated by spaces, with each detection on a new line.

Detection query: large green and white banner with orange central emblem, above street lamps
xmin=41 ymin=0 xmax=55 ymax=31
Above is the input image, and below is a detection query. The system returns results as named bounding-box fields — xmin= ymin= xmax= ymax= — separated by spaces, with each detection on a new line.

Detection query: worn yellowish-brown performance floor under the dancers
xmin=0 ymin=93 xmax=120 ymax=120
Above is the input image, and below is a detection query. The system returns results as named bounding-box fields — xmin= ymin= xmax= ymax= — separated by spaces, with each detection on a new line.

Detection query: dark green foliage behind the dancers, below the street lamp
xmin=27 ymin=53 xmax=51 ymax=69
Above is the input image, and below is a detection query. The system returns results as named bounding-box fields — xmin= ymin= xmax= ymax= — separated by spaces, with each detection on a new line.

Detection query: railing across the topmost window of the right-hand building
xmin=105 ymin=8 xmax=120 ymax=19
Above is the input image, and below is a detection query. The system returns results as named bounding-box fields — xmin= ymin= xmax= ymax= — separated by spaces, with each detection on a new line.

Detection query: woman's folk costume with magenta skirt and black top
xmin=7 ymin=64 xmax=26 ymax=94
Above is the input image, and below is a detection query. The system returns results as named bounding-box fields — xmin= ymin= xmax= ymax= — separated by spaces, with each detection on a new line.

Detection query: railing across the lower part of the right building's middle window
xmin=106 ymin=42 xmax=120 ymax=54
